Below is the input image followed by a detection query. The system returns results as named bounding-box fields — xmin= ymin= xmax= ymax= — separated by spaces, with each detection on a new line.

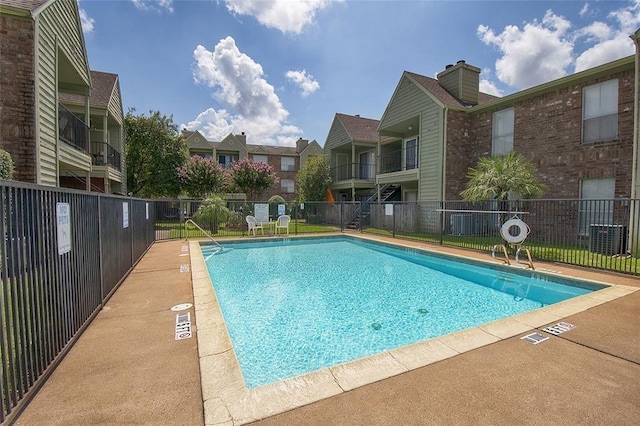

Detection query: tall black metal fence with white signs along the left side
xmin=0 ymin=181 xmax=155 ymax=423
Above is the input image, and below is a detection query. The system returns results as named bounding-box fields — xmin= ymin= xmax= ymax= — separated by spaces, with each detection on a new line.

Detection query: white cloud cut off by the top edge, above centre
xmin=225 ymin=0 xmax=342 ymax=34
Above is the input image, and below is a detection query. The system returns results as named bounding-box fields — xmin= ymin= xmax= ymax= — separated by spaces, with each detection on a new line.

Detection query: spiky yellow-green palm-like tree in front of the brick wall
xmin=460 ymin=151 xmax=545 ymax=201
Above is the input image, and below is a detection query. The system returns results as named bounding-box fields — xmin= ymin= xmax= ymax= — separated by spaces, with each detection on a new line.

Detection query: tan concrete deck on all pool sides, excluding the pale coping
xmin=17 ymin=241 xmax=640 ymax=425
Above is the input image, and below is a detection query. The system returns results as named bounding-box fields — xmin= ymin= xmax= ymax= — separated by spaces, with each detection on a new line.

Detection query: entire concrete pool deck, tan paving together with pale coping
xmin=17 ymin=236 xmax=640 ymax=425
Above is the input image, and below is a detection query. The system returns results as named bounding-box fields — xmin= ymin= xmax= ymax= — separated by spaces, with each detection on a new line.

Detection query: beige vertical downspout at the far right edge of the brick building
xmin=628 ymin=29 xmax=640 ymax=256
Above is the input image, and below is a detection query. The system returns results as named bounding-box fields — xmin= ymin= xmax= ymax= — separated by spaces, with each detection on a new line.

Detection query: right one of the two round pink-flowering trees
xmin=231 ymin=158 xmax=280 ymax=200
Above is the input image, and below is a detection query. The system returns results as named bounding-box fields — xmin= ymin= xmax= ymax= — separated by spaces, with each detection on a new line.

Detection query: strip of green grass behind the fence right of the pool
xmin=366 ymin=228 xmax=640 ymax=274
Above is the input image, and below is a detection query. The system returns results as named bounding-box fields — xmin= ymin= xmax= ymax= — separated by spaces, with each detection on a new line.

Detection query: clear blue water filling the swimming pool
xmin=202 ymin=237 xmax=596 ymax=388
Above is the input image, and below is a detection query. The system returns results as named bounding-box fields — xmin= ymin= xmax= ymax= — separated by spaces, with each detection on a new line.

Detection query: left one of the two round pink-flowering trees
xmin=177 ymin=155 xmax=229 ymax=199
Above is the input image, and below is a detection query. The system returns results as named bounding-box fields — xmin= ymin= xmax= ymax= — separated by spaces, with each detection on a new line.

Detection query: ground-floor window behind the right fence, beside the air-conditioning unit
xmin=579 ymin=178 xmax=616 ymax=235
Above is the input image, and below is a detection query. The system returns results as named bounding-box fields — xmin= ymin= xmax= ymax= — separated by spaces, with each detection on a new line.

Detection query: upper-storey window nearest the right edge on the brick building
xmin=582 ymin=80 xmax=618 ymax=143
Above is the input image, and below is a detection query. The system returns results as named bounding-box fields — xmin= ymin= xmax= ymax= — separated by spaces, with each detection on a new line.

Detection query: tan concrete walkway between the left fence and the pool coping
xmin=17 ymin=241 xmax=203 ymax=425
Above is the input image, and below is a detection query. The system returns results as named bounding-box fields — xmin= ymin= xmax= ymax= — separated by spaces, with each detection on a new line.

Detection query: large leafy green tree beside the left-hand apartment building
xmin=124 ymin=109 xmax=189 ymax=197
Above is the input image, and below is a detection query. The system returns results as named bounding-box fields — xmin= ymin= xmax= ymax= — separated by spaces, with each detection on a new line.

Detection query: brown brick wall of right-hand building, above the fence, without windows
xmin=456 ymin=69 xmax=634 ymax=199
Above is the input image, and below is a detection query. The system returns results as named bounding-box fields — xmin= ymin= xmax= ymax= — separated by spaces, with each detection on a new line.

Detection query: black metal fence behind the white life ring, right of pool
xmin=360 ymin=199 xmax=640 ymax=275
